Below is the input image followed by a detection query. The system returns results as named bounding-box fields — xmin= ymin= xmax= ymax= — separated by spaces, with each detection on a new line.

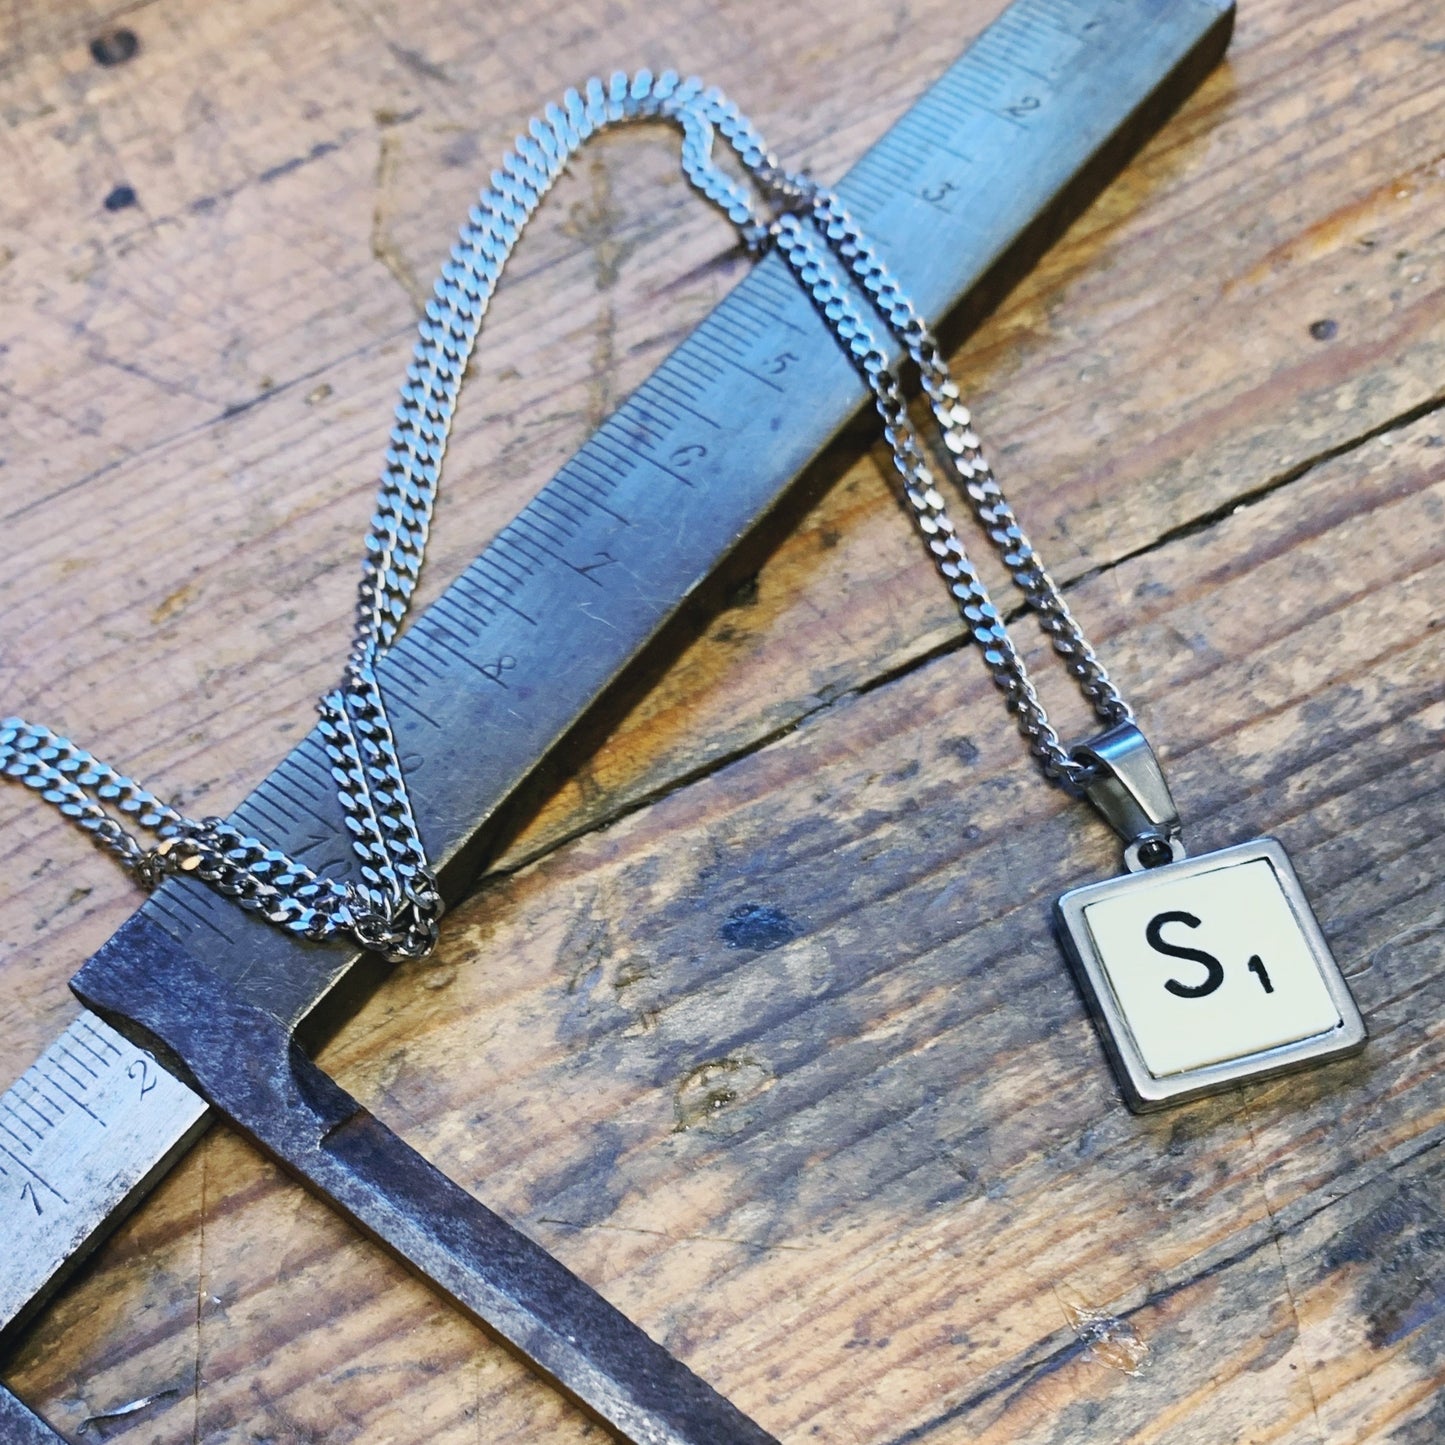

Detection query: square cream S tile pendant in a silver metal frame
xmin=1053 ymin=838 xmax=1366 ymax=1113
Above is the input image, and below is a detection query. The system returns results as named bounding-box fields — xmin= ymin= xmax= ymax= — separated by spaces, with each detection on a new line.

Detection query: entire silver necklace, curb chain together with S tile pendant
xmin=0 ymin=71 xmax=1366 ymax=1108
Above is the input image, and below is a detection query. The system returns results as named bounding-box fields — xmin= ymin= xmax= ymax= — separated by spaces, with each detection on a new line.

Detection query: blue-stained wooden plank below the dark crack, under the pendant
xmin=5 ymin=422 xmax=1445 ymax=1442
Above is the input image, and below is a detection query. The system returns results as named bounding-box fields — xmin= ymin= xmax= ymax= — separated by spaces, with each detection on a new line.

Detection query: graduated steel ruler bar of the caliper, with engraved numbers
xmin=0 ymin=0 xmax=1233 ymax=1421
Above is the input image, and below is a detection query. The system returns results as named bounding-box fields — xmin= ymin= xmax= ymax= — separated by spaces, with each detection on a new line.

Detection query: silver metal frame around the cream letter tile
xmin=1053 ymin=837 xmax=1368 ymax=1114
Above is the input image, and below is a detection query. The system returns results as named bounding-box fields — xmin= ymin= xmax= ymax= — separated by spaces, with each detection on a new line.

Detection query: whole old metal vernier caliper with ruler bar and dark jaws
xmin=0 ymin=0 xmax=1233 ymax=1445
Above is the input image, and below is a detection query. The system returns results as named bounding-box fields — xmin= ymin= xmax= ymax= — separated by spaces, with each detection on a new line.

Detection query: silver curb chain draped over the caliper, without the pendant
xmin=0 ymin=71 xmax=1130 ymax=958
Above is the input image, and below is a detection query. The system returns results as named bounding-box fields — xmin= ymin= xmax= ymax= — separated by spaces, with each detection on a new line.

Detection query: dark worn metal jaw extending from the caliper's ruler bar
xmin=77 ymin=922 xmax=776 ymax=1445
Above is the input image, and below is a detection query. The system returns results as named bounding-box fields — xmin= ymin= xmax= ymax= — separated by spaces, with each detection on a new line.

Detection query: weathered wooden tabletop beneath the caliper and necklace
xmin=0 ymin=0 xmax=1445 ymax=1445
